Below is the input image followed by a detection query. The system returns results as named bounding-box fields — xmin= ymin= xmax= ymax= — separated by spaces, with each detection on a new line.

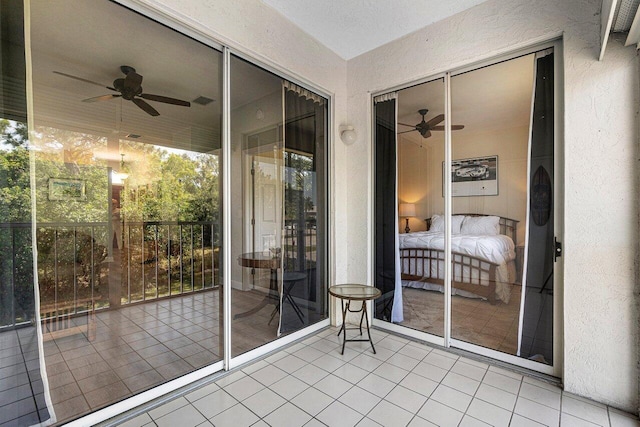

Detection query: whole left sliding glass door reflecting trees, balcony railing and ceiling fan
xmin=0 ymin=0 xmax=328 ymax=425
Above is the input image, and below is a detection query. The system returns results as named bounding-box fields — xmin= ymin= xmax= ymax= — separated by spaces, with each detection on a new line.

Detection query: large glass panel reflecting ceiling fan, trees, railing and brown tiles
xmin=30 ymin=0 xmax=223 ymax=422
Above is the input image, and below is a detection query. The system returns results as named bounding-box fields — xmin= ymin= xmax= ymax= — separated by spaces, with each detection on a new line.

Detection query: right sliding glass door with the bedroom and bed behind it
xmin=374 ymin=48 xmax=558 ymax=373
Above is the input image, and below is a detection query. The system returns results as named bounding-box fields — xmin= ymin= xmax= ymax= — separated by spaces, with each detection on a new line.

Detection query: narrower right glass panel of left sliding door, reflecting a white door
xmin=231 ymin=57 xmax=327 ymax=356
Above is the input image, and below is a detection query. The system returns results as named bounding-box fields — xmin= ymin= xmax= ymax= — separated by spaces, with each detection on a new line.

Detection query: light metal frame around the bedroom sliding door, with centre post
xmin=368 ymin=35 xmax=565 ymax=378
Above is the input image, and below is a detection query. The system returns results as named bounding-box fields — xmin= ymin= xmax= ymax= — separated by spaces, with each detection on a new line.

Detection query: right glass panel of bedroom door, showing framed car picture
xmin=448 ymin=50 xmax=553 ymax=363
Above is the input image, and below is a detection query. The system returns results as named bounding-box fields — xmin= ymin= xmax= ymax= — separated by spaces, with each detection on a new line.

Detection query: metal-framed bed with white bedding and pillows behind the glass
xmin=398 ymin=214 xmax=518 ymax=304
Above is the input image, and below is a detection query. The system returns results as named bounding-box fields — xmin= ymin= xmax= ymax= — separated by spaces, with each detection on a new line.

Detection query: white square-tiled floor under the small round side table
xmin=110 ymin=328 xmax=640 ymax=427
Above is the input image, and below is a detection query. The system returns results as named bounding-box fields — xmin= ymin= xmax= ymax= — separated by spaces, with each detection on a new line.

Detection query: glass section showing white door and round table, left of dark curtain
xmin=231 ymin=56 xmax=283 ymax=356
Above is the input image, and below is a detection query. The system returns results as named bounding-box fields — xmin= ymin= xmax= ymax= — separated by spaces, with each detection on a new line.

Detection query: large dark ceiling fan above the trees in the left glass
xmin=54 ymin=65 xmax=191 ymax=117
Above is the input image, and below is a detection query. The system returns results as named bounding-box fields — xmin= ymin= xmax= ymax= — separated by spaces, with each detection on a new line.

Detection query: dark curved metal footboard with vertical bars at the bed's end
xmin=400 ymin=248 xmax=498 ymax=304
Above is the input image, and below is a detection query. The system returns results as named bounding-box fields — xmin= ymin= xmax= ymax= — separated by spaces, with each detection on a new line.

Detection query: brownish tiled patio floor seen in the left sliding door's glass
xmin=0 ymin=290 xmax=290 ymax=427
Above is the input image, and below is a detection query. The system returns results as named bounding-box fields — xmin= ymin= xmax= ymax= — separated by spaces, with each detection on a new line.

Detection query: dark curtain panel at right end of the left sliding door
xmin=280 ymin=89 xmax=327 ymax=332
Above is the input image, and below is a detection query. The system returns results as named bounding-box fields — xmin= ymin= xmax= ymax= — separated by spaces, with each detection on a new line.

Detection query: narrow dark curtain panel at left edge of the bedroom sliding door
xmin=374 ymin=99 xmax=398 ymax=321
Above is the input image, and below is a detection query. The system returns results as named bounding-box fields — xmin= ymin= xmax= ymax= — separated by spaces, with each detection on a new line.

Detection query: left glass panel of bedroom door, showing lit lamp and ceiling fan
xmin=376 ymin=79 xmax=445 ymax=337
